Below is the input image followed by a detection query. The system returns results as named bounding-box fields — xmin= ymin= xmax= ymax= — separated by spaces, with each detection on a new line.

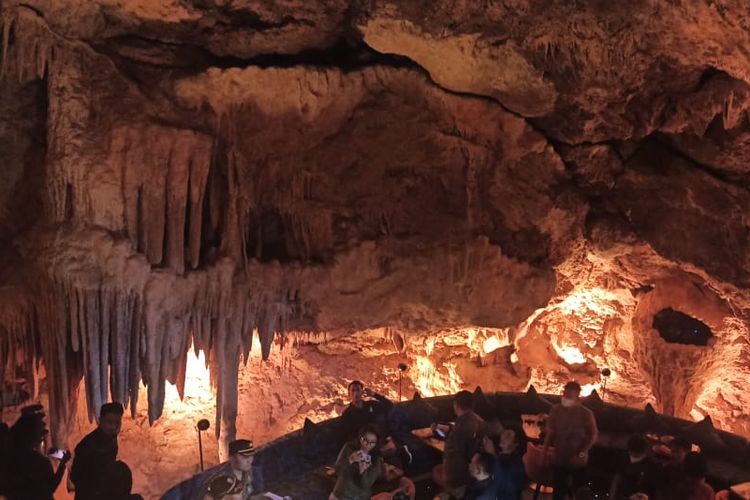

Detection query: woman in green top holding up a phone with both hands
xmin=329 ymin=425 xmax=383 ymax=500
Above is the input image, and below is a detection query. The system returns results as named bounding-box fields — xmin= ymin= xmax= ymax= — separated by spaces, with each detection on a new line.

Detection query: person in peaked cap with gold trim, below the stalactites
xmin=197 ymin=439 xmax=264 ymax=500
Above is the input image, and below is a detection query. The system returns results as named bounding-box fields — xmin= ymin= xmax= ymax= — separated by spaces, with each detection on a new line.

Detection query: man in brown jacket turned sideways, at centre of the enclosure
xmin=433 ymin=391 xmax=486 ymax=497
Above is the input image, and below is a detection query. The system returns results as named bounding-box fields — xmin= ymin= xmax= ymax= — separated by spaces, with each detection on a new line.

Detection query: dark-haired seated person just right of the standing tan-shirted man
xmin=609 ymin=435 xmax=660 ymax=500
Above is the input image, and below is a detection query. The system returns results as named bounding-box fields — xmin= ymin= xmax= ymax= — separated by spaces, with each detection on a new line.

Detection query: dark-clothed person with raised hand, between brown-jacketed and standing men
xmin=483 ymin=425 xmax=526 ymax=500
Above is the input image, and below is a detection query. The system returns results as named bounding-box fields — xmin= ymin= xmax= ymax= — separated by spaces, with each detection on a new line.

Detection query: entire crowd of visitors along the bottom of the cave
xmin=0 ymin=381 xmax=728 ymax=500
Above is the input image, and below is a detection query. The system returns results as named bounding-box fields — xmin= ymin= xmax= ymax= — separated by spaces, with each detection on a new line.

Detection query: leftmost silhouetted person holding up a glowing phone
xmin=7 ymin=405 xmax=70 ymax=500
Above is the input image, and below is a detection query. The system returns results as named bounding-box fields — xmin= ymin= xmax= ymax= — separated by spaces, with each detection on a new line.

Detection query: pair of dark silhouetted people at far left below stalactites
xmin=0 ymin=403 xmax=142 ymax=500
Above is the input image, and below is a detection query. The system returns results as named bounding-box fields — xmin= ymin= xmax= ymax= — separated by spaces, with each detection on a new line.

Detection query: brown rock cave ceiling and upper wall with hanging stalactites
xmin=0 ymin=0 xmax=750 ymax=446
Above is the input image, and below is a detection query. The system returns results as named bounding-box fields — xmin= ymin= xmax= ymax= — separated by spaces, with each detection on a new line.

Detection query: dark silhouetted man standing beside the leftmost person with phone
xmin=70 ymin=402 xmax=124 ymax=500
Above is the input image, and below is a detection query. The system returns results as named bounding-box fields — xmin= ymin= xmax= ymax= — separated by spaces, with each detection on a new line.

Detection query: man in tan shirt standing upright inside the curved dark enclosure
xmin=543 ymin=381 xmax=598 ymax=500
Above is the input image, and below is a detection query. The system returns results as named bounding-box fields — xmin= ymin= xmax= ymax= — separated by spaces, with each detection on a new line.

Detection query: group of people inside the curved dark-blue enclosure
xmin=329 ymin=381 xmax=714 ymax=500
